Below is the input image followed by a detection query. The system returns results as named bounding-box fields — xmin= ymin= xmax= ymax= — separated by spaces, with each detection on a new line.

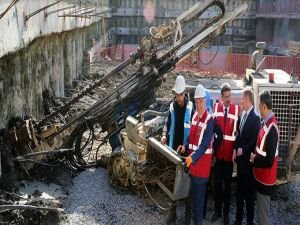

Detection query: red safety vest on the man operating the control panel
xmin=189 ymin=110 xmax=213 ymax=178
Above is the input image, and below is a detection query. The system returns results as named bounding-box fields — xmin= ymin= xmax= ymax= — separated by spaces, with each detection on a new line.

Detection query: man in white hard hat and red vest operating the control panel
xmin=178 ymin=84 xmax=214 ymax=225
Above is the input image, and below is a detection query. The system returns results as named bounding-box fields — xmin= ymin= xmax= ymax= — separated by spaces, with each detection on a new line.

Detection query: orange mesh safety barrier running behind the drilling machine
xmin=94 ymin=45 xmax=300 ymax=77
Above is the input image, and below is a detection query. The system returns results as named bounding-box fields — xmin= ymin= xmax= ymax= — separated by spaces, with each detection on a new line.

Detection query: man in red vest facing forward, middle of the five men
xmin=211 ymin=83 xmax=240 ymax=225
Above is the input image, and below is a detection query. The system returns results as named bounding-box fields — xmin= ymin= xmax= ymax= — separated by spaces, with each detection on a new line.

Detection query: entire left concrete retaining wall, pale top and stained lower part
xmin=0 ymin=0 xmax=107 ymax=128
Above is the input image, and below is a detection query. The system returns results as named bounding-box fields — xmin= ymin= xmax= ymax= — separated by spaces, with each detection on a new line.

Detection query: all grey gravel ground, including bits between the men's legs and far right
xmin=60 ymin=168 xmax=300 ymax=225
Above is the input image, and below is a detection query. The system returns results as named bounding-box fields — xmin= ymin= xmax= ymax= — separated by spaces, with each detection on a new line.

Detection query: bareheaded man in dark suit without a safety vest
xmin=232 ymin=89 xmax=260 ymax=225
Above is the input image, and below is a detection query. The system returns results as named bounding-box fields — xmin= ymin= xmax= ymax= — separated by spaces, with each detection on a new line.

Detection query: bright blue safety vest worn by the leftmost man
xmin=169 ymin=101 xmax=193 ymax=148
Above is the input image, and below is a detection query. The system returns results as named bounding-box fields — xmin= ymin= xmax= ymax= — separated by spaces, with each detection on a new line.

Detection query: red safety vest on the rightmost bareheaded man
xmin=253 ymin=115 xmax=279 ymax=186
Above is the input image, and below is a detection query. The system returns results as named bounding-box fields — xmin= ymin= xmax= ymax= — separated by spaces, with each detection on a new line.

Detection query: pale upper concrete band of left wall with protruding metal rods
xmin=0 ymin=0 xmax=101 ymax=58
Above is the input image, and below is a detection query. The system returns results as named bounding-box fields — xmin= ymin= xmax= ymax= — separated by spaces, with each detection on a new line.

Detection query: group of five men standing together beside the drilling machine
xmin=161 ymin=76 xmax=279 ymax=225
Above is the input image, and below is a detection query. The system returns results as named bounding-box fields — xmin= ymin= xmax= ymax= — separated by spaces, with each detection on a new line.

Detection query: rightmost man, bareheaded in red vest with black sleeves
xmin=250 ymin=91 xmax=279 ymax=225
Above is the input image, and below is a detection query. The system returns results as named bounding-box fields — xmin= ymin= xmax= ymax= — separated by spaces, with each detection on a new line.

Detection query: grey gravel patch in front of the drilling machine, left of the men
xmin=61 ymin=168 xmax=163 ymax=225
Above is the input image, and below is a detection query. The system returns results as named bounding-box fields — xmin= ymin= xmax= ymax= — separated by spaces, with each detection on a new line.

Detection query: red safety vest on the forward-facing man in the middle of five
xmin=214 ymin=103 xmax=240 ymax=162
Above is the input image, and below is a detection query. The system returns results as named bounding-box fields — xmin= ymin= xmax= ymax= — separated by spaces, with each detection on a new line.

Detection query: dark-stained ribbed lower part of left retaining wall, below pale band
xmin=0 ymin=23 xmax=99 ymax=128
